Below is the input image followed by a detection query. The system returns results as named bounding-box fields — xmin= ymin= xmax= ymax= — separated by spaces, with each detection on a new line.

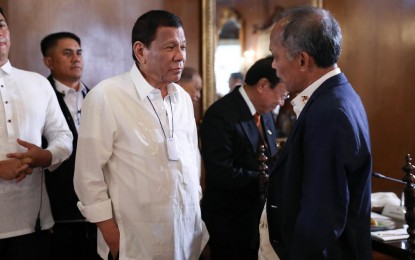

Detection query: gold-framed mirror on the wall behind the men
xmin=202 ymin=0 xmax=323 ymax=112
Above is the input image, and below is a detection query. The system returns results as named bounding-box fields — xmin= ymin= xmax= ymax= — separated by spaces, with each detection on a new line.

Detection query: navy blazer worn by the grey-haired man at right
xmin=267 ymin=74 xmax=372 ymax=260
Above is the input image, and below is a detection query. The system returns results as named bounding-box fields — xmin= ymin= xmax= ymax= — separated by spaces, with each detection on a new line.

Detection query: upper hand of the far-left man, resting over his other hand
xmin=7 ymin=139 xmax=52 ymax=169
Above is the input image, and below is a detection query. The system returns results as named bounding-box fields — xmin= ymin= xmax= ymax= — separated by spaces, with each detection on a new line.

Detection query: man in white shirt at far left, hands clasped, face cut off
xmin=0 ymin=8 xmax=72 ymax=260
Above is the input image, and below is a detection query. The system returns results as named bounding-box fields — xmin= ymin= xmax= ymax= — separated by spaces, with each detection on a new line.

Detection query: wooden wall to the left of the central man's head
xmin=0 ymin=0 xmax=180 ymax=87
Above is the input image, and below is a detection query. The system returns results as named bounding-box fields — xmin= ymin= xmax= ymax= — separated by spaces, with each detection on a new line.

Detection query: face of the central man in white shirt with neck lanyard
xmin=139 ymin=27 xmax=186 ymax=87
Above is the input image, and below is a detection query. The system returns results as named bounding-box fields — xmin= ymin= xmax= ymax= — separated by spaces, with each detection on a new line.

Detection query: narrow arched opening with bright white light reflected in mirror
xmin=215 ymin=8 xmax=243 ymax=96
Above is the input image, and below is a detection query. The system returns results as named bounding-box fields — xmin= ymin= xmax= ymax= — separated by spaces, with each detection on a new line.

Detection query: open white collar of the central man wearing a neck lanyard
xmin=130 ymin=64 xmax=178 ymax=103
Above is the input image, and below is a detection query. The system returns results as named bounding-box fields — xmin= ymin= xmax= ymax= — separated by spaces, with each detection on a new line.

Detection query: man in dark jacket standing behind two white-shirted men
xmin=41 ymin=32 xmax=100 ymax=259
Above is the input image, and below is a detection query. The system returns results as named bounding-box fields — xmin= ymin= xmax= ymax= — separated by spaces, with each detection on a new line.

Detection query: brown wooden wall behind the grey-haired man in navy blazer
xmin=324 ymin=0 xmax=415 ymax=194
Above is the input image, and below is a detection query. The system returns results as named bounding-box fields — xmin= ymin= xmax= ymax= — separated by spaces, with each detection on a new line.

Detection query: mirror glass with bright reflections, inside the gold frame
xmin=214 ymin=0 xmax=283 ymax=100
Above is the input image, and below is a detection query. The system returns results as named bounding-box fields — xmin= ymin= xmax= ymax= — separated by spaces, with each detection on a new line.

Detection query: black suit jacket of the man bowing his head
xmin=201 ymin=88 xmax=277 ymax=254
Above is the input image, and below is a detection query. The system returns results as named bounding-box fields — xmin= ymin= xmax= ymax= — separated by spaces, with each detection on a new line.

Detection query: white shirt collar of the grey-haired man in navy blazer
xmin=291 ymin=68 xmax=341 ymax=118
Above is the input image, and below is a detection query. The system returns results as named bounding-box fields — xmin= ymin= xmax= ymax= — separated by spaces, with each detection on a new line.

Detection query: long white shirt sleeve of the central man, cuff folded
xmin=74 ymin=89 xmax=116 ymax=223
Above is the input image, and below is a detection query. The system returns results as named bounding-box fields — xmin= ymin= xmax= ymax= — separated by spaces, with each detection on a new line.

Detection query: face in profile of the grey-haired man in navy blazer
xmin=269 ymin=22 xmax=302 ymax=93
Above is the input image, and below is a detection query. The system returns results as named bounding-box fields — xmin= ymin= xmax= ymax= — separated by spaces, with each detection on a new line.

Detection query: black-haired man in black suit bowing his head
xmin=201 ymin=57 xmax=287 ymax=260
